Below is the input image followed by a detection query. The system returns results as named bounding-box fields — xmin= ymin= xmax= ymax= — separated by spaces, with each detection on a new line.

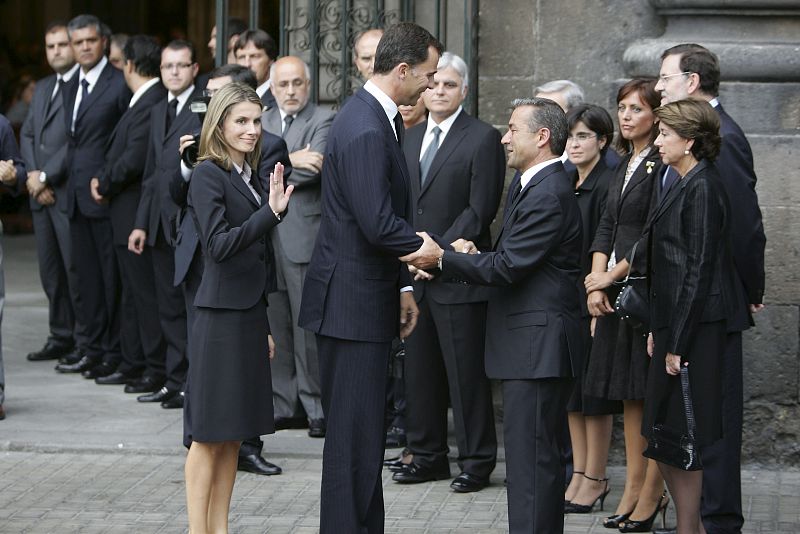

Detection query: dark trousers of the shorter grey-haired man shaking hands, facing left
xmin=503 ymin=378 xmax=573 ymax=534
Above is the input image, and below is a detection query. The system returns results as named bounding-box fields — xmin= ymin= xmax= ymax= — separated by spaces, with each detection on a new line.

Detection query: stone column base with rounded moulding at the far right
xmin=623 ymin=0 xmax=800 ymax=464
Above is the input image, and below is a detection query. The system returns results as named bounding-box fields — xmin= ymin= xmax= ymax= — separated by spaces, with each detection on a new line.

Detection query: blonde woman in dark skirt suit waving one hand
xmin=184 ymin=83 xmax=293 ymax=534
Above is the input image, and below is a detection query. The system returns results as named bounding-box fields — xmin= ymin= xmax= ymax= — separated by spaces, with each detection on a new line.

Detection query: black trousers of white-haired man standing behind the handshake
xmin=404 ymin=296 xmax=497 ymax=477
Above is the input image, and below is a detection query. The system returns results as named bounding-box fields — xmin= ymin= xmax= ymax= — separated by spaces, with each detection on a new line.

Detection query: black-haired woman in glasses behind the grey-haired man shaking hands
xmin=564 ymin=104 xmax=622 ymax=513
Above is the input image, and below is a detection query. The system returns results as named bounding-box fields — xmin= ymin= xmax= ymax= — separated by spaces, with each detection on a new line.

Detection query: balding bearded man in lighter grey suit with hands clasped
xmin=261 ymin=56 xmax=334 ymax=438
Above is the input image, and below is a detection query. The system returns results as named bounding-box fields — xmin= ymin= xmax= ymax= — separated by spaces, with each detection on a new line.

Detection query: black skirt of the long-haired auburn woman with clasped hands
xmin=583 ymin=285 xmax=650 ymax=400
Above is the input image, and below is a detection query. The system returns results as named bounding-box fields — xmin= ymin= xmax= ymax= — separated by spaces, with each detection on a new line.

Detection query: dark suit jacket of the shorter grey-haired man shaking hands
xmin=442 ymin=162 xmax=584 ymax=380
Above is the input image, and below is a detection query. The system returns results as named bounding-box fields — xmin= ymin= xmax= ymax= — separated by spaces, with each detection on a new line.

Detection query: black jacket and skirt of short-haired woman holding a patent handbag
xmin=642 ymin=161 xmax=747 ymax=446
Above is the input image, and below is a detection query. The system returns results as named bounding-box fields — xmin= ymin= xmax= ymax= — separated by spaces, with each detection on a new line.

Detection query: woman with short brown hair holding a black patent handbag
xmin=642 ymin=100 xmax=746 ymax=534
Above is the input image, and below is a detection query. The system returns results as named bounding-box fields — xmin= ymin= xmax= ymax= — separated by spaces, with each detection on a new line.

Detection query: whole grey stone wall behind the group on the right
xmin=479 ymin=0 xmax=800 ymax=465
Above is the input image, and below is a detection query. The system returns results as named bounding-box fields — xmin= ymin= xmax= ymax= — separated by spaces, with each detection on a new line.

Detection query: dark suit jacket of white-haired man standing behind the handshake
xmin=403 ymin=110 xmax=506 ymax=304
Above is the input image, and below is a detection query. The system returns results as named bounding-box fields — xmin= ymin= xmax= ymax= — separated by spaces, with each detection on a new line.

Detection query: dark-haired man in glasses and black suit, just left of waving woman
xmin=125 ymin=40 xmax=200 ymax=408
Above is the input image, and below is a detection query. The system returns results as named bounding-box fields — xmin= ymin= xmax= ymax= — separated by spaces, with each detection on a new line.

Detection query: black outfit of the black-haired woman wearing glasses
xmin=567 ymin=158 xmax=622 ymax=415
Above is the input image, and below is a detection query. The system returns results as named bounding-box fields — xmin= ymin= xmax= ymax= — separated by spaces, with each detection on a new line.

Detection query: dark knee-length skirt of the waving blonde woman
xmin=184 ymin=299 xmax=275 ymax=446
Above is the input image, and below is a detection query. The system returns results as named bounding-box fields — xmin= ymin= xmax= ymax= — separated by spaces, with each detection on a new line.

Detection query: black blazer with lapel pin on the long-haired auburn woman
xmin=589 ymin=148 xmax=663 ymax=275
